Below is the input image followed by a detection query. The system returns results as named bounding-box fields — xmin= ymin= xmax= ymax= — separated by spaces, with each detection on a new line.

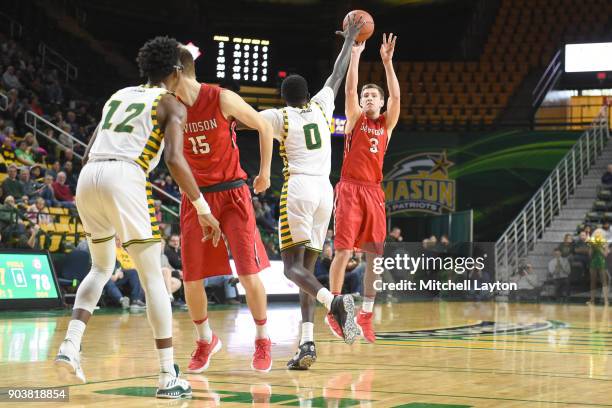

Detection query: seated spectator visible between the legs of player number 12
xmin=104 ymin=237 xmax=146 ymax=312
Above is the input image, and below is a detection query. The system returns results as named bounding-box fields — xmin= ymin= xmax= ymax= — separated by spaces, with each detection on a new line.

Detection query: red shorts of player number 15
xmin=181 ymin=184 xmax=270 ymax=281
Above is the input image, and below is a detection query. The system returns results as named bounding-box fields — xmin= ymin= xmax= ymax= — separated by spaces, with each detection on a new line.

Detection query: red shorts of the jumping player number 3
xmin=334 ymin=180 xmax=387 ymax=255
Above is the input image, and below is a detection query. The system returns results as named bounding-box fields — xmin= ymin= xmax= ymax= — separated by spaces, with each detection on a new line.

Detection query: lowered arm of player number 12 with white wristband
xmin=157 ymin=95 xmax=221 ymax=246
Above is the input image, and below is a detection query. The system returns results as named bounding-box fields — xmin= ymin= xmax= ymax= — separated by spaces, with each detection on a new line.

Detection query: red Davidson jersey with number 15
xmin=183 ymin=84 xmax=247 ymax=187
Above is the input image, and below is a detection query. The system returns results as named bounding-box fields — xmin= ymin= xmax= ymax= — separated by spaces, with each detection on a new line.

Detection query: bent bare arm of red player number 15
xmin=221 ymin=89 xmax=274 ymax=194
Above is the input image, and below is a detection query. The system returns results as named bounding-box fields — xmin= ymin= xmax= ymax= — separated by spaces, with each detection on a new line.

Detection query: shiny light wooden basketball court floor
xmin=0 ymin=302 xmax=612 ymax=408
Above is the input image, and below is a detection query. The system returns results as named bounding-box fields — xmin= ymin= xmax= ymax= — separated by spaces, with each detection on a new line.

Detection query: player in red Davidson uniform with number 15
xmin=176 ymin=47 xmax=273 ymax=373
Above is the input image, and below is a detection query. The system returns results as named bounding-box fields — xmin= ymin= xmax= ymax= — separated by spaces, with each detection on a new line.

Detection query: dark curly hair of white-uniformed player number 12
xmin=136 ymin=36 xmax=180 ymax=82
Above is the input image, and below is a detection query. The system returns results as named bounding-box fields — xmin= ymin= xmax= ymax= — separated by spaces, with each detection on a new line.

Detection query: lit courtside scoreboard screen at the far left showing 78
xmin=0 ymin=250 xmax=62 ymax=309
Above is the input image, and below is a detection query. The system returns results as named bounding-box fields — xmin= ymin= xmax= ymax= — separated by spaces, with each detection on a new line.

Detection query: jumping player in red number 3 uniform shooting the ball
xmin=325 ymin=34 xmax=400 ymax=343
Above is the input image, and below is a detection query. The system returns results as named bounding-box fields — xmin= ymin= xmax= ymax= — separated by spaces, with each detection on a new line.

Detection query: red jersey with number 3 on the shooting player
xmin=340 ymin=113 xmax=389 ymax=184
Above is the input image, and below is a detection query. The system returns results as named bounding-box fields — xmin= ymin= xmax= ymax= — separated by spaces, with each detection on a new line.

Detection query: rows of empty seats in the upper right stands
xmin=359 ymin=0 xmax=612 ymax=128
